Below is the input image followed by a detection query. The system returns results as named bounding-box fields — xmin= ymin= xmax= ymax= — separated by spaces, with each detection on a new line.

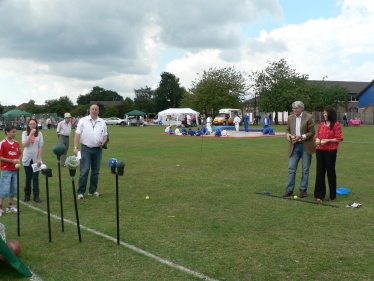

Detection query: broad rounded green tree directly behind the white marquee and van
xmin=181 ymin=67 xmax=249 ymax=113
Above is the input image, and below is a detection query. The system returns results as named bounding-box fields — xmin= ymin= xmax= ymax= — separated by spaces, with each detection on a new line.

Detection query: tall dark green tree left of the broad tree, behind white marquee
xmin=154 ymin=72 xmax=186 ymax=112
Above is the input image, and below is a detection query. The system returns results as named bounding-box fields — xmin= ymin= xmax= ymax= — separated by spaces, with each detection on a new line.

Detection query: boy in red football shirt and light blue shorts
xmin=0 ymin=124 xmax=22 ymax=217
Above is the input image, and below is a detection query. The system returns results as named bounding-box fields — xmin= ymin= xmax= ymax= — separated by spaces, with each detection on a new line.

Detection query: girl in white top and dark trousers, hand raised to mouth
xmin=22 ymin=118 xmax=44 ymax=203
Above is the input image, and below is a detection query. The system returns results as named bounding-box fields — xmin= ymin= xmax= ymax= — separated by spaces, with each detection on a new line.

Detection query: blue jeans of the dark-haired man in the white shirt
xmin=77 ymin=144 xmax=103 ymax=194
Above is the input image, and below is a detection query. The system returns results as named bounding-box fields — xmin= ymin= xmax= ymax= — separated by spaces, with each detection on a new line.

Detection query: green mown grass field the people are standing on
xmin=0 ymin=123 xmax=374 ymax=281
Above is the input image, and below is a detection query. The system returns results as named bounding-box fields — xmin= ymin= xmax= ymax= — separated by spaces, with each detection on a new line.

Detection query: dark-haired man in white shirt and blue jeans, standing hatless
xmin=74 ymin=104 xmax=108 ymax=199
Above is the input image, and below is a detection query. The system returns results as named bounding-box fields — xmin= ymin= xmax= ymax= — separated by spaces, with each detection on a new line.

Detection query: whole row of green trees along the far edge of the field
xmin=0 ymin=59 xmax=350 ymax=118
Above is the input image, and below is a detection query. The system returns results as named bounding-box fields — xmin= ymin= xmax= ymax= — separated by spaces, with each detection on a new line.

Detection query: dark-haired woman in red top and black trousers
xmin=314 ymin=106 xmax=343 ymax=202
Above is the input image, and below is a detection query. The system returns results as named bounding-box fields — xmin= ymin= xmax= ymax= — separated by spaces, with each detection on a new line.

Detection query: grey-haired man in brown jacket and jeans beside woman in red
xmin=283 ymin=101 xmax=316 ymax=198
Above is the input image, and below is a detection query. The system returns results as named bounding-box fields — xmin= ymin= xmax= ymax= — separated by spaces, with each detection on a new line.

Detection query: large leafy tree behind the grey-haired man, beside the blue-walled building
xmin=252 ymin=59 xmax=349 ymax=121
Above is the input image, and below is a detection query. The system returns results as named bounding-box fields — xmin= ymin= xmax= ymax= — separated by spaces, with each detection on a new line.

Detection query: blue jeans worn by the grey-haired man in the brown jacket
xmin=286 ymin=143 xmax=312 ymax=194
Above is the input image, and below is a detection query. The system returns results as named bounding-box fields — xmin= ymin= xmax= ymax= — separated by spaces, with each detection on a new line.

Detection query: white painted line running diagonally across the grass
xmin=19 ymin=201 xmax=220 ymax=281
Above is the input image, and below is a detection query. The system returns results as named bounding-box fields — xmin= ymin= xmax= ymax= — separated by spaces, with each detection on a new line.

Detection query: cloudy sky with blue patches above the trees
xmin=0 ymin=0 xmax=374 ymax=105
